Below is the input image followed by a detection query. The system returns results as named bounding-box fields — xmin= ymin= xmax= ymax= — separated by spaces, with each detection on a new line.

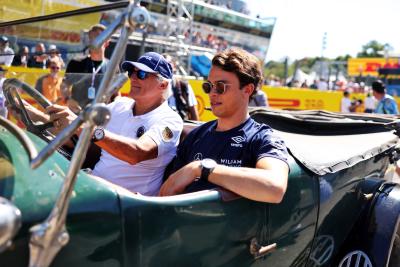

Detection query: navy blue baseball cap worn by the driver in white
xmin=121 ymin=52 xmax=172 ymax=79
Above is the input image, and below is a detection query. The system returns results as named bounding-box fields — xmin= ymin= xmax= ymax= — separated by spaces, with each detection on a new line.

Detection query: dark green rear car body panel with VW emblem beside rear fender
xmin=309 ymin=158 xmax=388 ymax=266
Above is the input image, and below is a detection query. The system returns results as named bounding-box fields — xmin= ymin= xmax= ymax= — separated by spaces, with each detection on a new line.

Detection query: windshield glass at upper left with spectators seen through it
xmin=0 ymin=3 xmax=131 ymax=112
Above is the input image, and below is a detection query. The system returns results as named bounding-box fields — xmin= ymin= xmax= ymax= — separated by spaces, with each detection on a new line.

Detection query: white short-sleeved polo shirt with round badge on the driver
xmin=92 ymin=97 xmax=183 ymax=195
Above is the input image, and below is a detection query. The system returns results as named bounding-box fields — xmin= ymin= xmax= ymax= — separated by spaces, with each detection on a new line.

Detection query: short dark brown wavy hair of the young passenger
xmin=212 ymin=47 xmax=264 ymax=94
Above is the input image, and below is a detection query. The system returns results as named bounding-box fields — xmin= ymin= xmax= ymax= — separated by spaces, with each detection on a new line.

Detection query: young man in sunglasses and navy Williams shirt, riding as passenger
xmin=160 ymin=48 xmax=289 ymax=203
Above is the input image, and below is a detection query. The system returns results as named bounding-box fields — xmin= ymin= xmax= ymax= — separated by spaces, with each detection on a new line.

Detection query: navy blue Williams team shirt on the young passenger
xmin=172 ymin=118 xmax=288 ymax=192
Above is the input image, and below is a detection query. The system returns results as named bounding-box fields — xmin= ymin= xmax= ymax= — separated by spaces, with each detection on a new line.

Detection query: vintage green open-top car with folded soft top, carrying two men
xmin=0 ymin=1 xmax=400 ymax=267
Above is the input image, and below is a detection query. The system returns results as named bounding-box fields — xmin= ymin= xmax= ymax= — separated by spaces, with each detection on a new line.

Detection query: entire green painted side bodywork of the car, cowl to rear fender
xmin=0 ymin=108 xmax=400 ymax=266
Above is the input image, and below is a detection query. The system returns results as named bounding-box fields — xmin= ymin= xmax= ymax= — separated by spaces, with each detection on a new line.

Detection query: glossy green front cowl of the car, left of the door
xmin=0 ymin=129 xmax=123 ymax=266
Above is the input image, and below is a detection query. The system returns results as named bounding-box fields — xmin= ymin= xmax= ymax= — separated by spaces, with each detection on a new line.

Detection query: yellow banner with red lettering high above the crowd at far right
xmin=347 ymin=58 xmax=400 ymax=76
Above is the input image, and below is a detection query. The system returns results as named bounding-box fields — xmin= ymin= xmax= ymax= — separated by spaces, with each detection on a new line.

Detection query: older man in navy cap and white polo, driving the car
xmin=18 ymin=52 xmax=183 ymax=195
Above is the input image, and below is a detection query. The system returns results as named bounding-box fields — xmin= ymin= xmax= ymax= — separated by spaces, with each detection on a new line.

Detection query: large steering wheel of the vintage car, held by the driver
xmin=3 ymin=78 xmax=53 ymax=140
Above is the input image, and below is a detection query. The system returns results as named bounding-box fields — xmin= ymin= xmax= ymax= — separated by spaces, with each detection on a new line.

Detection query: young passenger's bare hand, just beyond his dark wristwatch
xmin=159 ymin=161 xmax=201 ymax=196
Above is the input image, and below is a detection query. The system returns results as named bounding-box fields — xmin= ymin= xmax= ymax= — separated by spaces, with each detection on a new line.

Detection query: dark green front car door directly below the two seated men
xmin=121 ymin=190 xmax=268 ymax=266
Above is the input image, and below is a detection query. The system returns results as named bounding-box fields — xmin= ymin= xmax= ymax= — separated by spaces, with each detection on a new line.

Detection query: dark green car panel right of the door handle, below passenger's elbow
xmin=259 ymin=159 xmax=319 ymax=267
